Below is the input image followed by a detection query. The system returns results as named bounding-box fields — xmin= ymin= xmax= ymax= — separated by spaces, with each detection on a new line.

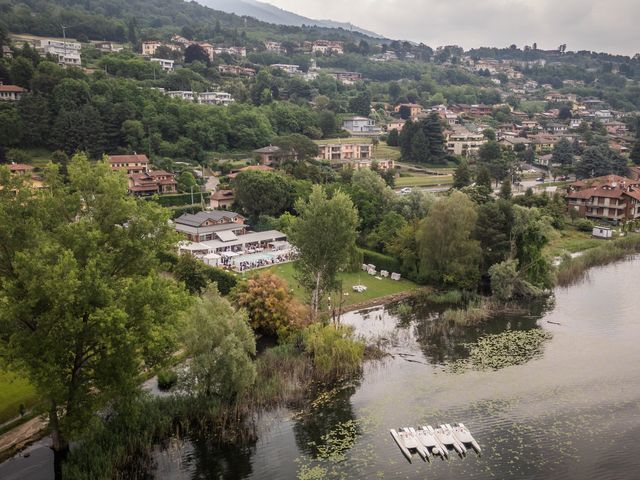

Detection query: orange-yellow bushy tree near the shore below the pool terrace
xmin=232 ymin=272 xmax=307 ymax=335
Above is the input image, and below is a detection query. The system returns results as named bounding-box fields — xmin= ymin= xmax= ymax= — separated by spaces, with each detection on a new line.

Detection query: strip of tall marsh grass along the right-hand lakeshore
xmin=556 ymin=233 xmax=640 ymax=287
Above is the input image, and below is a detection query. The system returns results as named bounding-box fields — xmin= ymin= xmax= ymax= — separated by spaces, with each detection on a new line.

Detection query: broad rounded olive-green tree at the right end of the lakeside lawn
xmin=417 ymin=191 xmax=481 ymax=290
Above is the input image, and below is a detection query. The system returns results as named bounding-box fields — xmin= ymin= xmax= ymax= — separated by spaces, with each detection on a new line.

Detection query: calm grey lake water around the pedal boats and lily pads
xmin=5 ymin=258 xmax=640 ymax=480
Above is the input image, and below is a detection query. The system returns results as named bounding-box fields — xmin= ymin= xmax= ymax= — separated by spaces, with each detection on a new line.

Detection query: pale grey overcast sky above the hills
xmin=266 ymin=0 xmax=640 ymax=55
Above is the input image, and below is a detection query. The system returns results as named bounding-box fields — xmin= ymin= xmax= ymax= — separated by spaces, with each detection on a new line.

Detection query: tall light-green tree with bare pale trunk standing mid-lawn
xmin=290 ymin=185 xmax=358 ymax=319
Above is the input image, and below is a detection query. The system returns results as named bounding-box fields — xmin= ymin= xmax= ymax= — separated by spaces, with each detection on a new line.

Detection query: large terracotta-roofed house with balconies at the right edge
xmin=567 ymin=175 xmax=640 ymax=222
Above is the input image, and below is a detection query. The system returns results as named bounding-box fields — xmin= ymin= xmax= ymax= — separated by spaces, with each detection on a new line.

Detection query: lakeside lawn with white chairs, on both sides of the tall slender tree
xmin=262 ymin=263 xmax=419 ymax=306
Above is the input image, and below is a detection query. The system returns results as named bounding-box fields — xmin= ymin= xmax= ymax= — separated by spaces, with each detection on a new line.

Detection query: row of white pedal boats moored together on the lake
xmin=389 ymin=423 xmax=482 ymax=463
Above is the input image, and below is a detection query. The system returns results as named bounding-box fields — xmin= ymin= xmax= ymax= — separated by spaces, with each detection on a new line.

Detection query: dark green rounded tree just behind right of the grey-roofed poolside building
xmin=233 ymin=171 xmax=295 ymax=223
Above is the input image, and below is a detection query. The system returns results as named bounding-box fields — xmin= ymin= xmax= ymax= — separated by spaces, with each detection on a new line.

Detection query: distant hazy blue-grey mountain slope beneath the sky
xmin=198 ymin=0 xmax=382 ymax=38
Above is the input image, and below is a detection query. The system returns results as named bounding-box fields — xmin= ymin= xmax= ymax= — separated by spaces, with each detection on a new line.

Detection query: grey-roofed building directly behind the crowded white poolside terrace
xmin=174 ymin=210 xmax=247 ymax=242
